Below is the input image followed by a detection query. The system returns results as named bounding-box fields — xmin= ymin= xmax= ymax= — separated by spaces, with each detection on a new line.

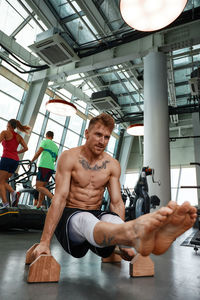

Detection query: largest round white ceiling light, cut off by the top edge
xmin=120 ymin=0 xmax=187 ymax=31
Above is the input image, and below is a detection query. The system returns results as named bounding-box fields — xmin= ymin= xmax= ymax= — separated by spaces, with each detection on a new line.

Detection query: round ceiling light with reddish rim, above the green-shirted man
xmin=46 ymin=99 xmax=77 ymax=117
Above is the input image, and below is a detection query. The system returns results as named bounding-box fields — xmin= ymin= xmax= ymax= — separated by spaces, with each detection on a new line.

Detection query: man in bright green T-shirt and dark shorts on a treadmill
xmin=31 ymin=131 xmax=58 ymax=208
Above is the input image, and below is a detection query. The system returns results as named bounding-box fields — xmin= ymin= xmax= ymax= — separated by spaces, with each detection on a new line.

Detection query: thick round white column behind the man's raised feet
xmin=144 ymin=52 xmax=171 ymax=206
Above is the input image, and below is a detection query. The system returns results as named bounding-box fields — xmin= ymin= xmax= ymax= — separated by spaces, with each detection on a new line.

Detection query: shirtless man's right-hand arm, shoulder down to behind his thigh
xmin=107 ymin=160 xmax=125 ymax=220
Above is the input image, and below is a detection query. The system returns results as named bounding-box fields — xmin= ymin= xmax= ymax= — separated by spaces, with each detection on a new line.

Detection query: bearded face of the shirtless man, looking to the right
xmin=85 ymin=122 xmax=111 ymax=155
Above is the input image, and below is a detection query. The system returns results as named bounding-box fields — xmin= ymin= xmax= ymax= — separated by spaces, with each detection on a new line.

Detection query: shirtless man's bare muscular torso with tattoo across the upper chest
xmin=66 ymin=147 xmax=114 ymax=209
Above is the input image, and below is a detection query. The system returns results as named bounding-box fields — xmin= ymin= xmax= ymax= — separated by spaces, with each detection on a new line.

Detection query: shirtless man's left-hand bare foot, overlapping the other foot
xmin=124 ymin=206 xmax=175 ymax=256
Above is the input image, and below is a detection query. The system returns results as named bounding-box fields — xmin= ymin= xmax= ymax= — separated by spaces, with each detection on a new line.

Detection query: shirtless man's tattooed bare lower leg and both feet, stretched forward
xmin=94 ymin=202 xmax=197 ymax=256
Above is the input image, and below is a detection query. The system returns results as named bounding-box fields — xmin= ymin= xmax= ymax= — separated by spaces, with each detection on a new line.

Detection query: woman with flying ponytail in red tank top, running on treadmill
xmin=0 ymin=119 xmax=31 ymax=207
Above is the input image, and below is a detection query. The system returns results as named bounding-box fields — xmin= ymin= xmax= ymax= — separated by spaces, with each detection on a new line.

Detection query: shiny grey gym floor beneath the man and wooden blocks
xmin=0 ymin=229 xmax=200 ymax=300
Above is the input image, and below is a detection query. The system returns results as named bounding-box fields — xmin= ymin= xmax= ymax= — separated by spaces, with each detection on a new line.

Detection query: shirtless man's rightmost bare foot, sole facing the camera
xmin=152 ymin=201 xmax=197 ymax=255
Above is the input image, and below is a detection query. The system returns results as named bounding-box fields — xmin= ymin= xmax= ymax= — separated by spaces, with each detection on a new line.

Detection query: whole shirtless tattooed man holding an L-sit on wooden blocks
xmin=33 ymin=113 xmax=197 ymax=260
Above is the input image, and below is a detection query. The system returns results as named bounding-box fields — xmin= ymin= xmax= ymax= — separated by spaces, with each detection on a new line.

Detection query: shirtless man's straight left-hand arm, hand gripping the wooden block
xmin=34 ymin=151 xmax=73 ymax=257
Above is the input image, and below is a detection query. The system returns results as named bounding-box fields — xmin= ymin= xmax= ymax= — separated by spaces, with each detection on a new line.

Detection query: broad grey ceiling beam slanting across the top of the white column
xmin=33 ymin=21 xmax=200 ymax=80
